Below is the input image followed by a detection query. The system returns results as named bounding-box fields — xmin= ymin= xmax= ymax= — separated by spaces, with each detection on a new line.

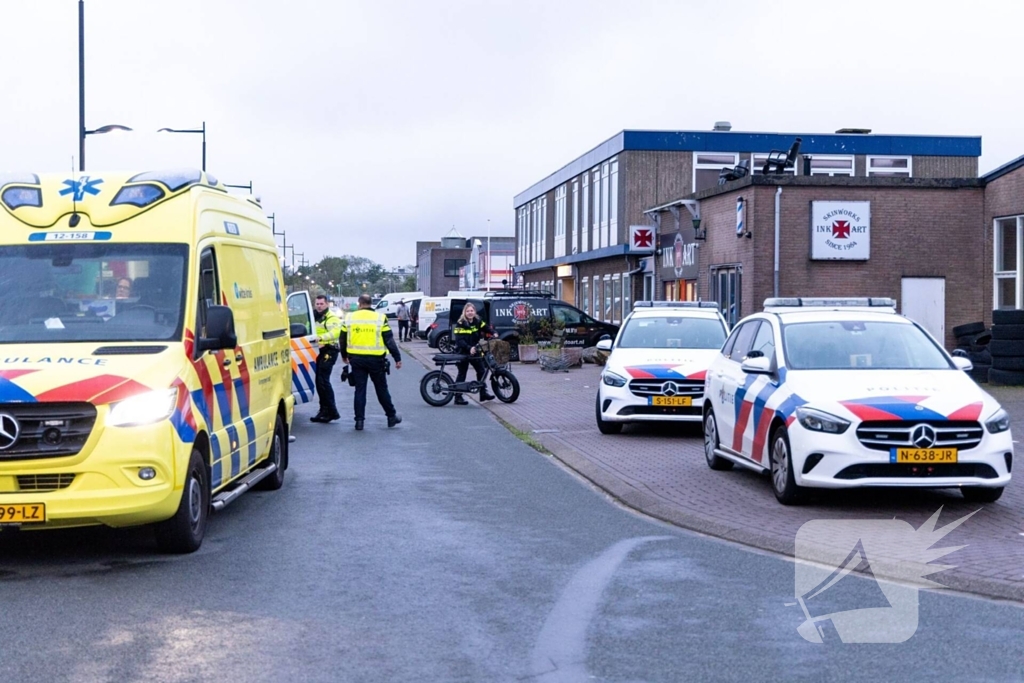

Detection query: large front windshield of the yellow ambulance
xmin=0 ymin=242 xmax=188 ymax=344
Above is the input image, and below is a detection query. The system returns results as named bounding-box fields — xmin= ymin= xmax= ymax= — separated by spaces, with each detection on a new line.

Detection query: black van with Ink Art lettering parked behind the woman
xmin=446 ymin=289 xmax=618 ymax=360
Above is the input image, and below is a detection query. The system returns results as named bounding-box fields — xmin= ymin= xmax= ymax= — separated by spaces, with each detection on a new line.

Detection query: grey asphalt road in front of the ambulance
xmin=0 ymin=361 xmax=1024 ymax=683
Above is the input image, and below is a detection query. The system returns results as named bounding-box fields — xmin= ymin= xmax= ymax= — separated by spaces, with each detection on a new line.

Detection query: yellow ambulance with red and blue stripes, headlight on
xmin=0 ymin=170 xmax=315 ymax=552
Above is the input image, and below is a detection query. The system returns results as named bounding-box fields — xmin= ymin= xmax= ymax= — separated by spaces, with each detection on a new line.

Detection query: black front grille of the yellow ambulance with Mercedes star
xmin=0 ymin=401 xmax=96 ymax=462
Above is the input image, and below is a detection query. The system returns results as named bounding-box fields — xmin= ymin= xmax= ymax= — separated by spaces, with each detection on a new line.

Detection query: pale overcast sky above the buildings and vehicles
xmin=0 ymin=0 xmax=1024 ymax=267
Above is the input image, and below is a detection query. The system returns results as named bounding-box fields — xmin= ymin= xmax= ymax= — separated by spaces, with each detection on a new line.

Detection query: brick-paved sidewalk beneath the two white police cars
xmin=402 ymin=341 xmax=1024 ymax=601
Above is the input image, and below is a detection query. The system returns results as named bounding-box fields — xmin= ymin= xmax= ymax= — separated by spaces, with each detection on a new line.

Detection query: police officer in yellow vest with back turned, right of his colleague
xmin=339 ymin=294 xmax=401 ymax=430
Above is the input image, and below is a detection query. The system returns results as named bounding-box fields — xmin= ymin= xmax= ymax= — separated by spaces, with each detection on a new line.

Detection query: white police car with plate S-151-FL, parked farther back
xmin=596 ymin=301 xmax=729 ymax=434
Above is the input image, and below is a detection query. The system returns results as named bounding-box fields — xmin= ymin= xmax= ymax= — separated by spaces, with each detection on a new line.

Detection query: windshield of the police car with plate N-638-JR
xmin=782 ymin=321 xmax=952 ymax=370
